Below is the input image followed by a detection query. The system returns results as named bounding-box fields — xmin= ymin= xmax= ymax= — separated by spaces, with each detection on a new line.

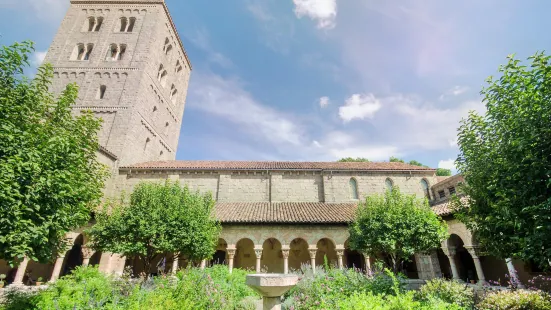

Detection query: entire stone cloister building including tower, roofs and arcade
xmin=0 ymin=0 xmax=544 ymax=284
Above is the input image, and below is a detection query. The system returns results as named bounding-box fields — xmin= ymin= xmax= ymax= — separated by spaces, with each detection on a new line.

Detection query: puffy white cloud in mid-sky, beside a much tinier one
xmin=339 ymin=94 xmax=381 ymax=122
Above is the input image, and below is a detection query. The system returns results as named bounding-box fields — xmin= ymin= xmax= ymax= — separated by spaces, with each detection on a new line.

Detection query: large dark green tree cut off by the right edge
xmin=456 ymin=53 xmax=551 ymax=267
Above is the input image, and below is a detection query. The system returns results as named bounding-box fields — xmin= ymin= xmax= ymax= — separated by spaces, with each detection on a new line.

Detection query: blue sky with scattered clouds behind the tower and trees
xmin=0 ymin=0 xmax=551 ymax=171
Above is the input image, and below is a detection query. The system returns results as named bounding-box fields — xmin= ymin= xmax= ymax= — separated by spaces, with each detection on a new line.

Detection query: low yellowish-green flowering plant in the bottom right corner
xmin=477 ymin=290 xmax=551 ymax=310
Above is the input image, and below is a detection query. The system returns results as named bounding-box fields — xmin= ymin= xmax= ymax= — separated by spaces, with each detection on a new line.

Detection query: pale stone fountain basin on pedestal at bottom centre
xmin=246 ymin=273 xmax=298 ymax=310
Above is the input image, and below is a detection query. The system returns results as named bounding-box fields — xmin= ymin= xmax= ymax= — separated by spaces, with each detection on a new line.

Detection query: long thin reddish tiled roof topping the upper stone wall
xmin=122 ymin=160 xmax=435 ymax=171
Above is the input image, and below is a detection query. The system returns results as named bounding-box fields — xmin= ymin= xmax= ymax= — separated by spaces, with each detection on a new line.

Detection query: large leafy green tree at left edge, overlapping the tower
xmin=0 ymin=42 xmax=107 ymax=264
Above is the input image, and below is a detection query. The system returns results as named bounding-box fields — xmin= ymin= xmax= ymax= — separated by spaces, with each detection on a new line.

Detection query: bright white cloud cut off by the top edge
xmin=293 ymin=0 xmax=337 ymax=29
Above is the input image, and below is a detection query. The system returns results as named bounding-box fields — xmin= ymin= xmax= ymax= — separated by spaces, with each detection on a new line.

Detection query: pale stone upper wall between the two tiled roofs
xmin=111 ymin=168 xmax=435 ymax=202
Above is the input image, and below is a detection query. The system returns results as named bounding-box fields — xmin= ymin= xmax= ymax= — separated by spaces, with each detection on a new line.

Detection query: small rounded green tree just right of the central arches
xmin=349 ymin=187 xmax=448 ymax=272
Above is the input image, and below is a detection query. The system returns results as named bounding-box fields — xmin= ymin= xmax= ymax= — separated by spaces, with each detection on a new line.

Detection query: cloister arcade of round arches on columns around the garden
xmin=0 ymin=220 xmax=540 ymax=284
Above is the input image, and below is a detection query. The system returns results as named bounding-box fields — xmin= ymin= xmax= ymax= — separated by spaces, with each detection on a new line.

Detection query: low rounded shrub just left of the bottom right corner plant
xmin=416 ymin=279 xmax=474 ymax=309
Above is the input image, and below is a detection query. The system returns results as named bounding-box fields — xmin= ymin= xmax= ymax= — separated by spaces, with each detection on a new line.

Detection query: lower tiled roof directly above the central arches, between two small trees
xmin=214 ymin=202 xmax=357 ymax=224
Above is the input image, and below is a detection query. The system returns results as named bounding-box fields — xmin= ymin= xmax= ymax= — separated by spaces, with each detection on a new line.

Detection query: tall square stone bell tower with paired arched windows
xmin=45 ymin=0 xmax=191 ymax=166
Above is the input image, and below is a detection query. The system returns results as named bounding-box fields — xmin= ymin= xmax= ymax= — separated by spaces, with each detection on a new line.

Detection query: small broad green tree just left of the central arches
xmin=88 ymin=181 xmax=221 ymax=275
